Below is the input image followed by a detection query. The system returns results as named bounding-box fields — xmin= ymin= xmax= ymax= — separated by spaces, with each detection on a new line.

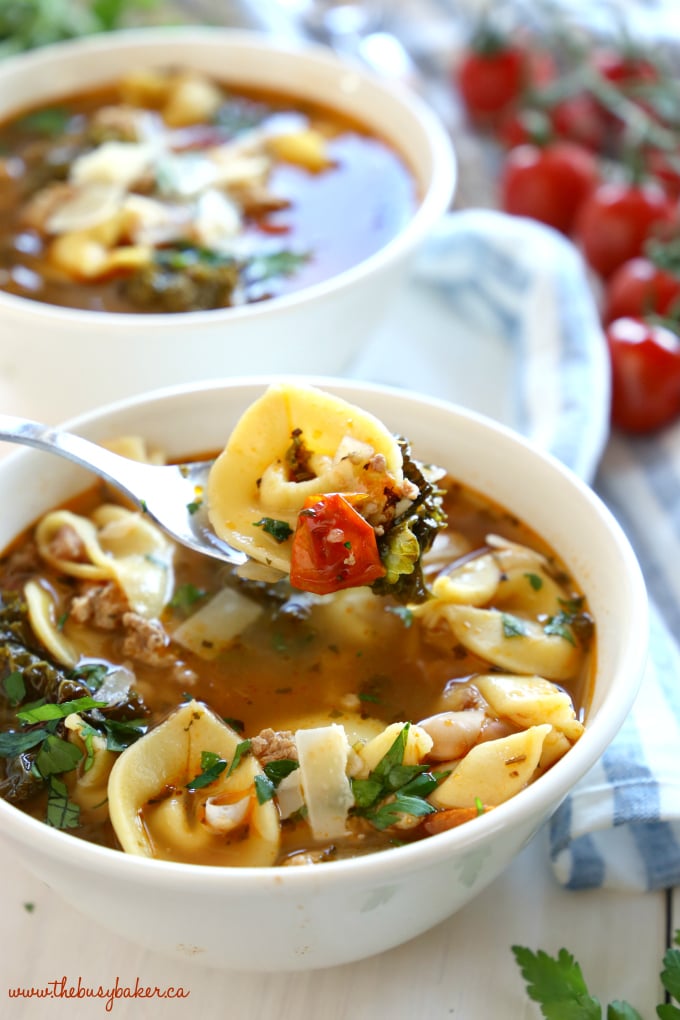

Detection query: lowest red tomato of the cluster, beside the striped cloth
xmin=607 ymin=316 xmax=680 ymax=432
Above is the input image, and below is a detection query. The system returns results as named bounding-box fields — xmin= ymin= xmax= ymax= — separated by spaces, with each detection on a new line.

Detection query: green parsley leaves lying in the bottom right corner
xmin=512 ymin=929 xmax=680 ymax=1020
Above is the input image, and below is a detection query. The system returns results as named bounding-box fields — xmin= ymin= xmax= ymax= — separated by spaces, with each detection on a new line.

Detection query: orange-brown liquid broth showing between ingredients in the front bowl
xmin=0 ymin=467 xmax=594 ymax=864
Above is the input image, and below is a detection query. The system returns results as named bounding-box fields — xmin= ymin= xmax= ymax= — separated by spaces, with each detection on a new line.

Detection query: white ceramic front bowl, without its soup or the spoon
xmin=0 ymin=378 xmax=646 ymax=970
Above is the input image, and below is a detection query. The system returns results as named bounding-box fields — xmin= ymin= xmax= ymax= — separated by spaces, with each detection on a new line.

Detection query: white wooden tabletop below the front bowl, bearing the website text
xmin=0 ymin=832 xmax=668 ymax=1020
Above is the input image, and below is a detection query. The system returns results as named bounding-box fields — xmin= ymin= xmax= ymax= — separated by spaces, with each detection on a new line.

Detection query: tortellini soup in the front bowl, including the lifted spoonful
xmin=0 ymin=383 xmax=594 ymax=866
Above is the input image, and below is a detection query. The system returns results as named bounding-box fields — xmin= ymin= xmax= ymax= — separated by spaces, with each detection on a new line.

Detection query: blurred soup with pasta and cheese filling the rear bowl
xmin=0 ymin=69 xmax=418 ymax=313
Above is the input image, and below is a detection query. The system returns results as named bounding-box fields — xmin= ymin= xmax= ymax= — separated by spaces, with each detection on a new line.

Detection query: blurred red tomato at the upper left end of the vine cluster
xmin=457 ymin=36 xmax=526 ymax=125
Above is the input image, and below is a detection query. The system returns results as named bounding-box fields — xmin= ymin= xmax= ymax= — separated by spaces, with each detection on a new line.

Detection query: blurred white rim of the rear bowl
xmin=0 ymin=26 xmax=458 ymax=330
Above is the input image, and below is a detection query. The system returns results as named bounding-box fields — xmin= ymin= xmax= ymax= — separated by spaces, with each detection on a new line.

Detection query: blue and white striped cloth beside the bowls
xmin=349 ymin=210 xmax=680 ymax=889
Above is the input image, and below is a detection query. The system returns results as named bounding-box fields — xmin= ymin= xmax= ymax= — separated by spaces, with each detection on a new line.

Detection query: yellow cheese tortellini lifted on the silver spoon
xmin=207 ymin=383 xmax=408 ymax=572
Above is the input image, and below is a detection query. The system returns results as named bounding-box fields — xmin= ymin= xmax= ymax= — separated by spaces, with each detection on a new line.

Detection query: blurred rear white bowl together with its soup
xmin=0 ymin=28 xmax=455 ymax=413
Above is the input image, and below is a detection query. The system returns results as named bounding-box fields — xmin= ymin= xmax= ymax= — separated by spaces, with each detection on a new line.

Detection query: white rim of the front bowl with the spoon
xmin=0 ymin=374 xmax=647 ymax=895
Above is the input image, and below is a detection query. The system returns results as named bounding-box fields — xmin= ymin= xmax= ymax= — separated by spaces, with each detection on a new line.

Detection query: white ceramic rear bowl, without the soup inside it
xmin=0 ymin=27 xmax=456 ymax=420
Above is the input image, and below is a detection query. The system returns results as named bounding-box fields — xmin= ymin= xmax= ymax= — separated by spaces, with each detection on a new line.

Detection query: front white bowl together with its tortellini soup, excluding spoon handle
xmin=0 ymin=379 xmax=645 ymax=970
